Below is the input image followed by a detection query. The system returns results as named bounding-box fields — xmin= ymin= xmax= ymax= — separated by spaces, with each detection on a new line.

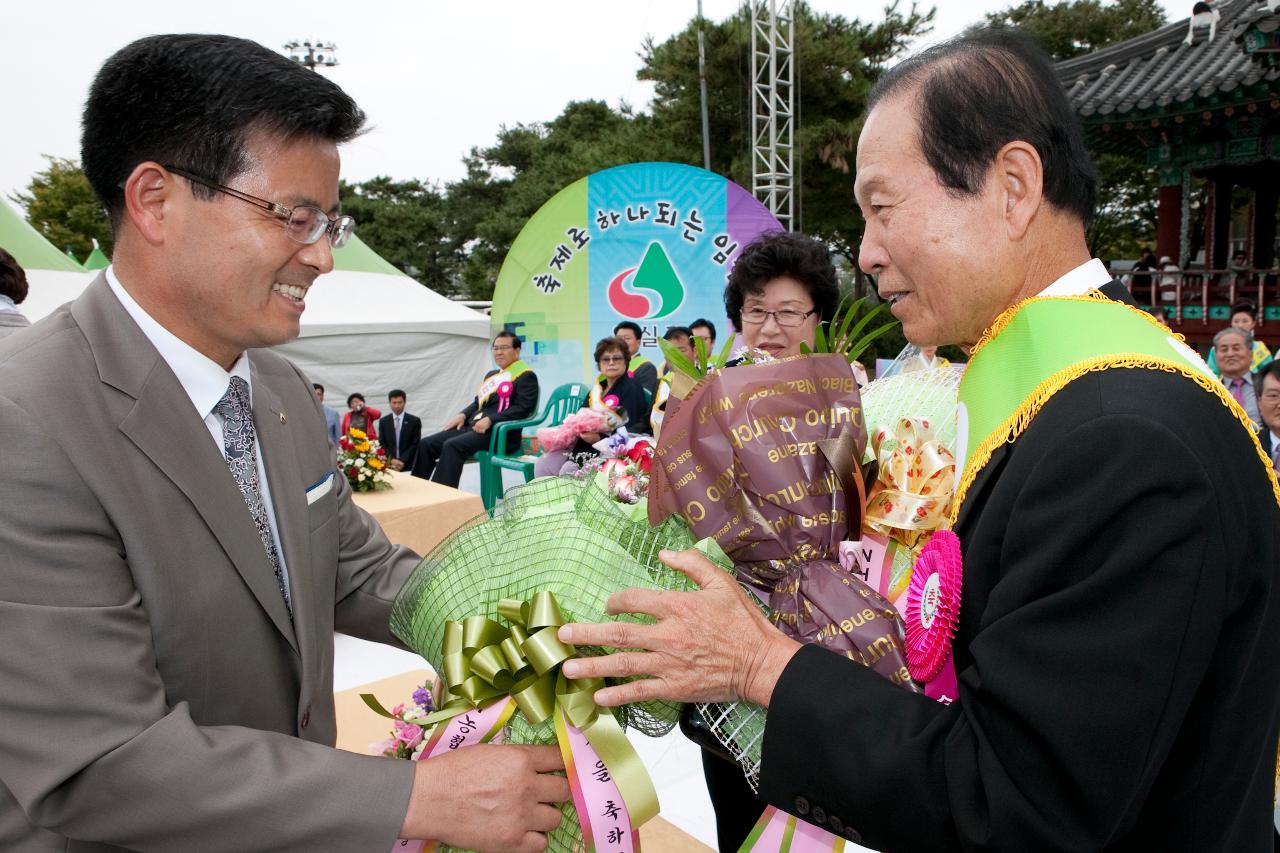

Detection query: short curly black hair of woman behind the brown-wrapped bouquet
xmin=724 ymin=231 xmax=840 ymax=332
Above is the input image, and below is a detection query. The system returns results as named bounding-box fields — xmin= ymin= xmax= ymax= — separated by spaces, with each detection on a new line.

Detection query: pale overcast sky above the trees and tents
xmin=0 ymin=0 xmax=1190 ymax=197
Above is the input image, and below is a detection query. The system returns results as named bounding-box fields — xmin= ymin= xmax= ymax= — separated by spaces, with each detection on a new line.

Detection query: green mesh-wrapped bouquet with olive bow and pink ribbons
xmin=366 ymin=471 xmax=730 ymax=853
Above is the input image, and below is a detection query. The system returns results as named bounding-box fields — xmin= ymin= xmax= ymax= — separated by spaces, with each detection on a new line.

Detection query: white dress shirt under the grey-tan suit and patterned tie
xmin=106 ymin=266 xmax=289 ymax=588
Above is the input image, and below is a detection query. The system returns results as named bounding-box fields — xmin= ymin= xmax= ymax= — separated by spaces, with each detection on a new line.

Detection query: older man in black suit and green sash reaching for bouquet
xmin=561 ymin=31 xmax=1280 ymax=852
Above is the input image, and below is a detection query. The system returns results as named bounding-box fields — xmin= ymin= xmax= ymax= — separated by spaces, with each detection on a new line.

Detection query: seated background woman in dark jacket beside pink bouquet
xmin=534 ymin=337 xmax=649 ymax=476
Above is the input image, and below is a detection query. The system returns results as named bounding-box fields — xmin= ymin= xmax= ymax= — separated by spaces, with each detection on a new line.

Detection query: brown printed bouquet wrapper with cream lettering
xmin=649 ymin=355 xmax=915 ymax=690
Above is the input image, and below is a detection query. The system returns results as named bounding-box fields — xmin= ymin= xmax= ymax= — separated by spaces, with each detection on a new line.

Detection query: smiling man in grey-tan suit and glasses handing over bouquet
xmin=0 ymin=36 xmax=567 ymax=852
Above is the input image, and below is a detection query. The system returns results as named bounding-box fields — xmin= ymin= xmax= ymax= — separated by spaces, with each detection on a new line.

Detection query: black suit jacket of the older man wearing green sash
xmin=760 ymin=280 xmax=1280 ymax=852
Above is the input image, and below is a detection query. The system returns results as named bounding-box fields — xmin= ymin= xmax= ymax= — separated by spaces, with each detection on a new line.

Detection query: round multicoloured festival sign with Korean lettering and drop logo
xmin=492 ymin=163 xmax=782 ymax=398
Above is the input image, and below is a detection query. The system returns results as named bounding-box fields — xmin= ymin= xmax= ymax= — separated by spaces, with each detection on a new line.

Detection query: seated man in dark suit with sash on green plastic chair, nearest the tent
xmin=412 ymin=332 xmax=538 ymax=488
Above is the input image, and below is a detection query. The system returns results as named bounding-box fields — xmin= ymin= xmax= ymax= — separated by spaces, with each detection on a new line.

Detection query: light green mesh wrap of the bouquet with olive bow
xmin=390 ymin=476 xmax=732 ymax=853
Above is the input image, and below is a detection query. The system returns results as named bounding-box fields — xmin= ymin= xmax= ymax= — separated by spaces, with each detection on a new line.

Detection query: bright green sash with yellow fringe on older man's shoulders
xmin=951 ymin=291 xmax=1280 ymax=524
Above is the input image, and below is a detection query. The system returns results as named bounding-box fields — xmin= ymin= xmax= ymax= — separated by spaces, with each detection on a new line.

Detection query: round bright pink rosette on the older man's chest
xmin=906 ymin=530 xmax=964 ymax=684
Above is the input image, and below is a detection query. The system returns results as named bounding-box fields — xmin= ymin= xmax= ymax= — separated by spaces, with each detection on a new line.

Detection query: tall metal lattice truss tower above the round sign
xmin=748 ymin=0 xmax=795 ymax=231
